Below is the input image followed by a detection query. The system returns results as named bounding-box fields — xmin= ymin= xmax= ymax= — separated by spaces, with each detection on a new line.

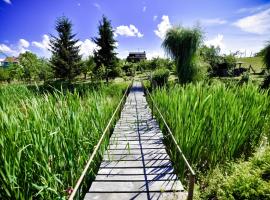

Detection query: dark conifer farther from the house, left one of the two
xmin=50 ymin=17 xmax=81 ymax=82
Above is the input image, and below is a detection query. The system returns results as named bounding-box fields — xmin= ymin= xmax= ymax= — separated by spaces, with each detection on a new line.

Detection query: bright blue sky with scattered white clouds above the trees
xmin=0 ymin=0 xmax=270 ymax=58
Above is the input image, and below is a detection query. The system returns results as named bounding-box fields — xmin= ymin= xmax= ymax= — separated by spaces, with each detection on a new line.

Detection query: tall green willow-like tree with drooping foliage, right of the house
xmin=162 ymin=27 xmax=202 ymax=83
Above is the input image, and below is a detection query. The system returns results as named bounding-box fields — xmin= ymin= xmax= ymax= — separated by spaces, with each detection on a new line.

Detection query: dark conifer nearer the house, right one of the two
xmin=92 ymin=16 xmax=116 ymax=83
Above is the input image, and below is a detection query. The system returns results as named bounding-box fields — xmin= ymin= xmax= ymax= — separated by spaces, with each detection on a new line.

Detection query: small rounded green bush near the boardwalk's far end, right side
xmin=151 ymin=68 xmax=170 ymax=87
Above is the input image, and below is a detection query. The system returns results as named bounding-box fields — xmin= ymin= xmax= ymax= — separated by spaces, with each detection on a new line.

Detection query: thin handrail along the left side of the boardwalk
xmin=68 ymin=80 xmax=133 ymax=200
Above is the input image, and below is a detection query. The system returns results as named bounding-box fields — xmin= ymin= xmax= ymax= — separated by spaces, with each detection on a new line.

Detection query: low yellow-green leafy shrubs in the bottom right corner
xmin=200 ymin=148 xmax=270 ymax=200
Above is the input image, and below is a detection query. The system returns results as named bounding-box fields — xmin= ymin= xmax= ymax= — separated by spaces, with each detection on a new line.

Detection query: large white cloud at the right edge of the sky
xmin=233 ymin=9 xmax=270 ymax=34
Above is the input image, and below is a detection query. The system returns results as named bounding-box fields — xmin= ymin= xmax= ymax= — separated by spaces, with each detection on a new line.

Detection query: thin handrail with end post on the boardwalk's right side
xmin=142 ymin=82 xmax=196 ymax=200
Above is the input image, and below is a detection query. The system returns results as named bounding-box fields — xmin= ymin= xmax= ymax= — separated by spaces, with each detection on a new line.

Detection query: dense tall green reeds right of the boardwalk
xmin=152 ymin=83 xmax=269 ymax=171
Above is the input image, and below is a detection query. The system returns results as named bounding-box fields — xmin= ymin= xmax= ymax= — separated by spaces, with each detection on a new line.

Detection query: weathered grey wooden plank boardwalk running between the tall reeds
xmin=85 ymin=82 xmax=187 ymax=200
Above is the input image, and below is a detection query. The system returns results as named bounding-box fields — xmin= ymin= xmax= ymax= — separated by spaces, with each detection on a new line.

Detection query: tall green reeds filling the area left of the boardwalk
xmin=0 ymin=84 xmax=127 ymax=199
